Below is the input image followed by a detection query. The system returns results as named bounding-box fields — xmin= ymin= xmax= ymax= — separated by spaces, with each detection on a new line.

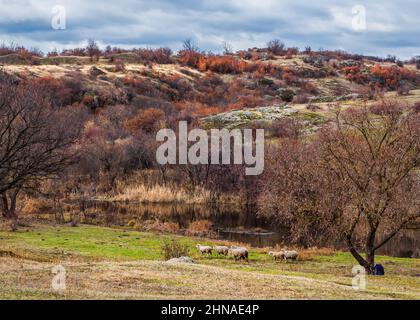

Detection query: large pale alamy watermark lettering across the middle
xmin=156 ymin=121 xmax=264 ymax=176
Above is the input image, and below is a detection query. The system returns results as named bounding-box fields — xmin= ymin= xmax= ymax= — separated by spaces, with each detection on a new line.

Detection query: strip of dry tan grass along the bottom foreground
xmin=0 ymin=257 xmax=416 ymax=299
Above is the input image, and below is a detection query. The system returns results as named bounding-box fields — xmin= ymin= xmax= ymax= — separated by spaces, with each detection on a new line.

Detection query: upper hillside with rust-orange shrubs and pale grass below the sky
xmin=0 ymin=49 xmax=420 ymax=130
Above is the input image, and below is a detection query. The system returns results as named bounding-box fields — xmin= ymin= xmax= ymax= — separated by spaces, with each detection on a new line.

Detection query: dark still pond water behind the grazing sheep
xmin=76 ymin=201 xmax=420 ymax=257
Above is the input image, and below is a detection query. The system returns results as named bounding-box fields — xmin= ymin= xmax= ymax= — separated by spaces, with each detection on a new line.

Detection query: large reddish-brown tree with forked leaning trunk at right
xmin=260 ymin=101 xmax=420 ymax=273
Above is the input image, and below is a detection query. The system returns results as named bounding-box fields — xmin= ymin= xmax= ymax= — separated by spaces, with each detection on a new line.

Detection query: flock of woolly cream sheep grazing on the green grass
xmin=196 ymin=244 xmax=299 ymax=261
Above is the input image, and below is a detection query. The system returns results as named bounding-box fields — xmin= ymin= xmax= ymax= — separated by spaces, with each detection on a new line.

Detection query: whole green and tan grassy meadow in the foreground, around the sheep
xmin=0 ymin=224 xmax=420 ymax=299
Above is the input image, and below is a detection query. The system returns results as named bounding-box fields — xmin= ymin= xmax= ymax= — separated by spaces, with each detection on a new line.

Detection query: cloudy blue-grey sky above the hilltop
xmin=0 ymin=0 xmax=420 ymax=59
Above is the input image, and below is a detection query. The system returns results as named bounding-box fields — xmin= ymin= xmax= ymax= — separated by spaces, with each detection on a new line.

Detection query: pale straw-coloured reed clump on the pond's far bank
xmin=110 ymin=184 xmax=210 ymax=204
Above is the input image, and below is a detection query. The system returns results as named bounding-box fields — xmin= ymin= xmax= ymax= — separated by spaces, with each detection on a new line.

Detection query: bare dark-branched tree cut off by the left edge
xmin=0 ymin=75 xmax=78 ymax=218
